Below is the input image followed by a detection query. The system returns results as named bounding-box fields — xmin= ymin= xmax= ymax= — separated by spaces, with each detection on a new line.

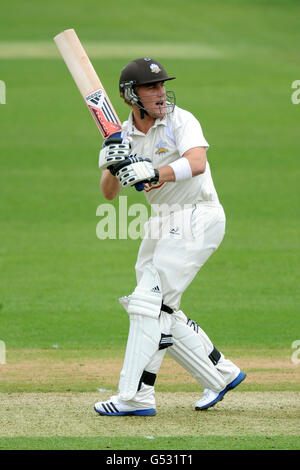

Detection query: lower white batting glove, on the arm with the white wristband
xmin=116 ymin=157 xmax=159 ymax=187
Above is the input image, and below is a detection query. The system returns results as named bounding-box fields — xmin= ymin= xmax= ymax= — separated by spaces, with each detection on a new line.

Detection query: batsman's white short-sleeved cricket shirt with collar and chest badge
xmin=123 ymin=106 xmax=220 ymax=206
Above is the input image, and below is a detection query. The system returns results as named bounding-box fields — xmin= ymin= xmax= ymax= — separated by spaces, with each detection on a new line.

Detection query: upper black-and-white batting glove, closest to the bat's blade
xmin=99 ymin=138 xmax=131 ymax=174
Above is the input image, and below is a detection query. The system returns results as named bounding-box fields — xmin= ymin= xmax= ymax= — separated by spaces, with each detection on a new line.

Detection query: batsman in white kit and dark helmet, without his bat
xmin=94 ymin=57 xmax=246 ymax=416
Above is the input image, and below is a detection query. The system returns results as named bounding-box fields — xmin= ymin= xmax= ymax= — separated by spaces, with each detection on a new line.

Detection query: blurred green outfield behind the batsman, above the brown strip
xmin=0 ymin=0 xmax=300 ymax=349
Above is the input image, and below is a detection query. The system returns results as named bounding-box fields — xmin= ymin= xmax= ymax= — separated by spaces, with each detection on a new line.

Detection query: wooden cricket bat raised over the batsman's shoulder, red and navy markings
xmin=54 ymin=29 xmax=144 ymax=191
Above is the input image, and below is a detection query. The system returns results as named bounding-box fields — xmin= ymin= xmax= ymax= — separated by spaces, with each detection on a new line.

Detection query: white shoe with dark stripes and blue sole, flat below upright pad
xmin=94 ymin=395 xmax=156 ymax=416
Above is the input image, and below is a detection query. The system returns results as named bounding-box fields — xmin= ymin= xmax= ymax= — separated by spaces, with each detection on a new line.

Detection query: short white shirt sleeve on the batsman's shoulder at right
xmin=175 ymin=111 xmax=209 ymax=156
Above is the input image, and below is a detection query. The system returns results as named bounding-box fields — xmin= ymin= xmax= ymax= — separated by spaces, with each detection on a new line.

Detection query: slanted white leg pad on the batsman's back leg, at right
xmin=168 ymin=310 xmax=227 ymax=392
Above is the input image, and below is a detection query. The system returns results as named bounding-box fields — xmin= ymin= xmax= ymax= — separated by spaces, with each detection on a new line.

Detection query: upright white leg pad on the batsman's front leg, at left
xmin=119 ymin=264 xmax=162 ymax=401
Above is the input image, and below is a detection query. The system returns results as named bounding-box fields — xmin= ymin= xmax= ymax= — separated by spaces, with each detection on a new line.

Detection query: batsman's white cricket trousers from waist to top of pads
xmin=135 ymin=203 xmax=226 ymax=310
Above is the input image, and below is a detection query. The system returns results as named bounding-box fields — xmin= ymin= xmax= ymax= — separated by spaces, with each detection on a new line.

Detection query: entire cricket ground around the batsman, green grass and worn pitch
xmin=0 ymin=0 xmax=300 ymax=450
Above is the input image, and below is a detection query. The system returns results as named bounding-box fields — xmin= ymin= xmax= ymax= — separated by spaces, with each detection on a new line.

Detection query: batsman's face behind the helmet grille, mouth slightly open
xmin=137 ymin=82 xmax=166 ymax=119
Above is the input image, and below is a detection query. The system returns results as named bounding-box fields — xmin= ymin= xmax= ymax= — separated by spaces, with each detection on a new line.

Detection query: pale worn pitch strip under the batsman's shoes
xmin=0 ymin=391 xmax=300 ymax=438
